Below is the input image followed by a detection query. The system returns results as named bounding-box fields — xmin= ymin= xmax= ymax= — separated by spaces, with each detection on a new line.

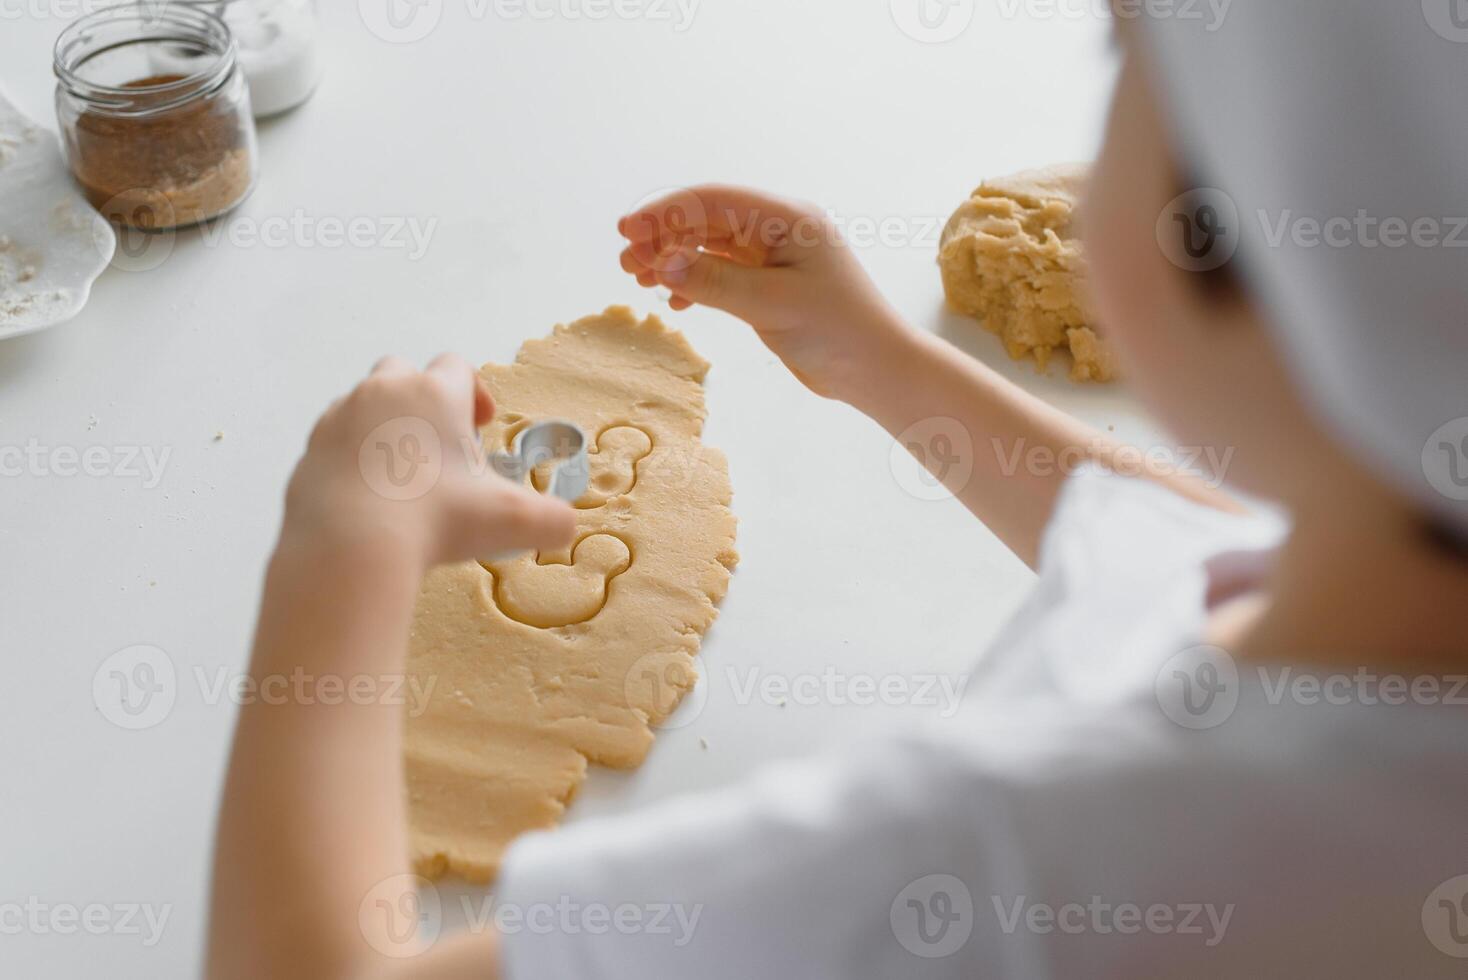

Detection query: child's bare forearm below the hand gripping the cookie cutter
xmin=208 ymin=533 xmax=493 ymax=979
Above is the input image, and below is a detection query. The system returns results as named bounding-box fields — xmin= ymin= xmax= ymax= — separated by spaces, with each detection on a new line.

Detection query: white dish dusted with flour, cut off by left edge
xmin=0 ymin=92 xmax=117 ymax=339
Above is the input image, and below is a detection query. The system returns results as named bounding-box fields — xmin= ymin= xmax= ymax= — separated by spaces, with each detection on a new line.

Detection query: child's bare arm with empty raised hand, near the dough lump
xmin=618 ymin=186 xmax=1236 ymax=565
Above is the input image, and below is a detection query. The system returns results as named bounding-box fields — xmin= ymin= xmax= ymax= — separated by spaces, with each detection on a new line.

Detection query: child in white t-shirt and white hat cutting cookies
xmin=208 ymin=0 xmax=1468 ymax=980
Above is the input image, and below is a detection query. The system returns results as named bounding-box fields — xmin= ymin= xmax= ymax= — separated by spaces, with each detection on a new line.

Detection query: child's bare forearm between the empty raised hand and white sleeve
xmin=843 ymin=319 xmax=1236 ymax=566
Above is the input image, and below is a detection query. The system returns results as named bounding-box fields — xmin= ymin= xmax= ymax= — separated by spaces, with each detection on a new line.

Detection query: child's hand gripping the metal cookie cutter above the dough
xmin=282 ymin=355 xmax=575 ymax=568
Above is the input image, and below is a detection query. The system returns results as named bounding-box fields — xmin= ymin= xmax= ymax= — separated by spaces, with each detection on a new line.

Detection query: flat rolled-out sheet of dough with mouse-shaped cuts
xmin=404 ymin=307 xmax=738 ymax=882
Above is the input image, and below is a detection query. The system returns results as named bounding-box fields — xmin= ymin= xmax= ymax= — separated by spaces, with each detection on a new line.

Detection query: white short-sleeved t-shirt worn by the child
xmin=499 ymin=469 xmax=1468 ymax=980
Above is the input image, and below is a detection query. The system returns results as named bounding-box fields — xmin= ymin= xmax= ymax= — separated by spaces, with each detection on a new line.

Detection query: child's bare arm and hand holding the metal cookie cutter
xmin=208 ymin=358 xmax=574 ymax=980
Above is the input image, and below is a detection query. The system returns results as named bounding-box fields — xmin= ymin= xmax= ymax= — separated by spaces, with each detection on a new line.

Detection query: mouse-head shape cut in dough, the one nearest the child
xmin=484 ymin=534 xmax=633 ymax=629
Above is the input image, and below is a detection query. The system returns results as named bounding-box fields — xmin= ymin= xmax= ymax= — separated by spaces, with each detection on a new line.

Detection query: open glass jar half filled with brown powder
xmin=54 ymin=3 xmax=257 ymax=230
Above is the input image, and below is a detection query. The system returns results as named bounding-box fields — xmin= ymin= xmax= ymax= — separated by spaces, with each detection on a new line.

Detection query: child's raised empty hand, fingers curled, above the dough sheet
xmin=617 ymin=186 xmax=906 ymax=399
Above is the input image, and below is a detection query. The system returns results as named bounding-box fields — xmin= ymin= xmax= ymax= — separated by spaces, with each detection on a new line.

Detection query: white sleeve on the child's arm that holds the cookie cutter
xmin=498 ymin=736 xmax=1020 ymax=980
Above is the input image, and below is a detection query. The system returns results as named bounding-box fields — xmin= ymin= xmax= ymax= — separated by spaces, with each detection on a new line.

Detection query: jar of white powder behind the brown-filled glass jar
xmin=154 ymin=0 xmax=321 ymax=119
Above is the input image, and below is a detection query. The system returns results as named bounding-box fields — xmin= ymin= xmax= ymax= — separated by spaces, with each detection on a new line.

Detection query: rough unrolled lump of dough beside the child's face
xmin=938 ymin=164 xmax=1116 ymax=381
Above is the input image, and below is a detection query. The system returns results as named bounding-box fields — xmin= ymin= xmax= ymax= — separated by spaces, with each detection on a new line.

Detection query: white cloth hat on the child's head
xmin=1142 ymin=0 xmax=1468 ymax=531
